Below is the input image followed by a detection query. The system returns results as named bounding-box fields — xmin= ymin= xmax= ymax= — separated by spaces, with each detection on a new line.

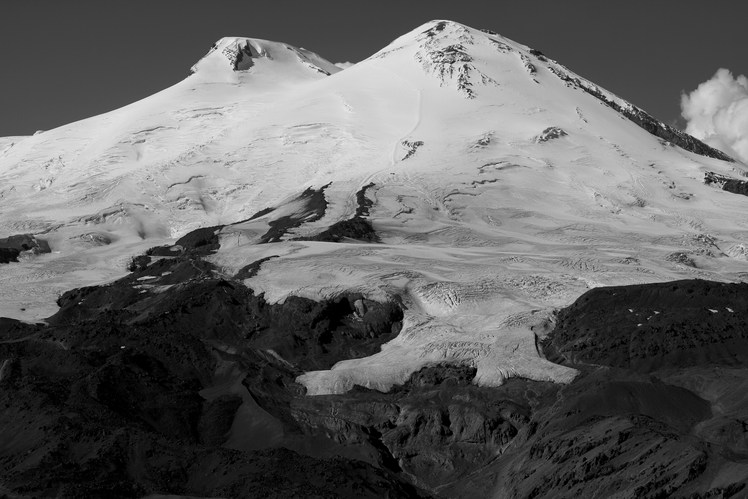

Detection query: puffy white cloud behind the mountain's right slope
xmin=680 ymin=69 xmax=748 ymax=164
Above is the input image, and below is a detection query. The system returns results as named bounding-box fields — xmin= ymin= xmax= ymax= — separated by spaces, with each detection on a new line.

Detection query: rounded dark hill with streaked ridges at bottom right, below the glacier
xmin=476 ymin=371 xmax=720 ymax=498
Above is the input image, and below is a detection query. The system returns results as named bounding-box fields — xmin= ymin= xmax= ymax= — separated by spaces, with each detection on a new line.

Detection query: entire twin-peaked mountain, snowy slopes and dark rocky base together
xmin=0 ymin=21 xmax=748 ymax=497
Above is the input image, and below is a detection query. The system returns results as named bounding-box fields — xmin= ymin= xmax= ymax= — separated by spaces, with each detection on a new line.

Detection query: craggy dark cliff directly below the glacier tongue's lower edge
xmin=292 ymin=365 xmax=542 ymax=490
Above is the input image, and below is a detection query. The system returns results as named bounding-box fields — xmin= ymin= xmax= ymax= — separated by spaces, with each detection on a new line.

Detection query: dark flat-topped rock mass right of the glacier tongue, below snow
xmin=544 ymin=280 xmax=748 ymax=372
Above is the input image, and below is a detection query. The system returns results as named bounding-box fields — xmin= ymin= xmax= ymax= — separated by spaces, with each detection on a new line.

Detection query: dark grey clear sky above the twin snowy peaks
xmin=0 ymin=0 xmax=748 ymax=136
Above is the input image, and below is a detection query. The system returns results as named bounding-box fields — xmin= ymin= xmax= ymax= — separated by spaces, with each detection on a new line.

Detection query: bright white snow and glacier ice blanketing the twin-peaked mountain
xmin=0 ymin=21 xmax=748 ymax=394
